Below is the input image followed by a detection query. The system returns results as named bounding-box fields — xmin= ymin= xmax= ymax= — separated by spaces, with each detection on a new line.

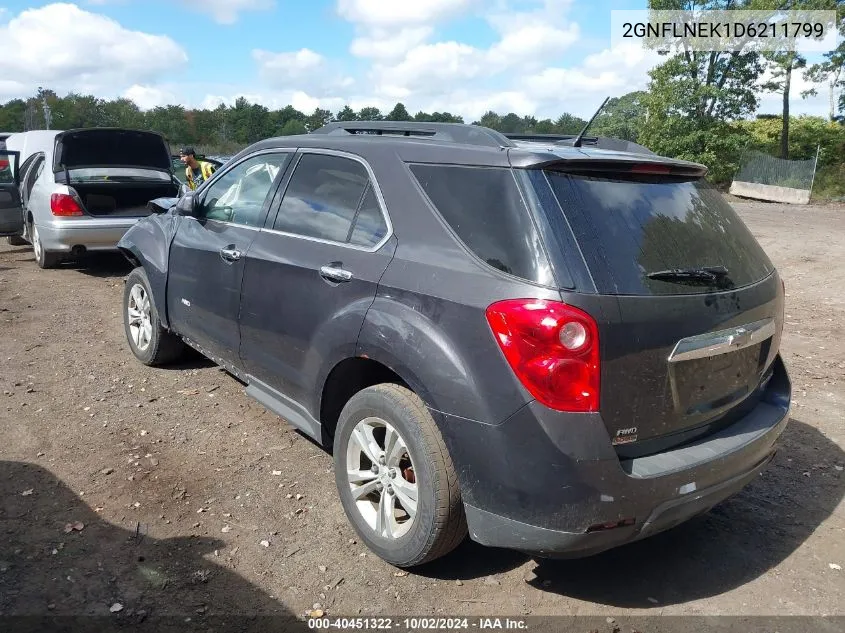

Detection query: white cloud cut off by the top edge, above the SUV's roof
xmin=337 ymin=0 xmax=477 ymax=27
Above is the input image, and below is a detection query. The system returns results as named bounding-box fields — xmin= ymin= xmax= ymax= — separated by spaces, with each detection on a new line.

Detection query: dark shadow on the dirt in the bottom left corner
xmin=0 ymin=461 xmax=307 ymax=632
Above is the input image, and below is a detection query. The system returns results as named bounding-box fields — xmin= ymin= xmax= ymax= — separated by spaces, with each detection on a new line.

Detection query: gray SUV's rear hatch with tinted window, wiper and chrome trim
xmin=529 ymin=161 xmax=783 ymax=457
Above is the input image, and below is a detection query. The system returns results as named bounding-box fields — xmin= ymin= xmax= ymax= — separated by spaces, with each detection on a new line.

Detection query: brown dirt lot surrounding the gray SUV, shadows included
xmin=0 ymin=203 xmax=845 ymax=621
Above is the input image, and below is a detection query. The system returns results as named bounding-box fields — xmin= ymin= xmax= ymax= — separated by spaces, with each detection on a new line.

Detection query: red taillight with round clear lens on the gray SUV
xmin=487 ymin=299 xmax=600 ymax=412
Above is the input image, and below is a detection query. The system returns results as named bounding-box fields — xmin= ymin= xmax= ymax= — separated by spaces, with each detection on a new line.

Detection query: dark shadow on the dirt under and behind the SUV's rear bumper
xmin=416 ymin=419 xmax=845 ymax=608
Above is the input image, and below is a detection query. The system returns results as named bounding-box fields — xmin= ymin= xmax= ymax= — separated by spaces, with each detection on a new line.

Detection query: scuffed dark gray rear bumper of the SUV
xmin=433 ymin=357 xmax=791 ymax=557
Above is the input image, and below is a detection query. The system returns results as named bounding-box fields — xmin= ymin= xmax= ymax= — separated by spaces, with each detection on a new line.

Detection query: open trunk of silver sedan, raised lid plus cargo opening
xmin=53 ymin=128 xmax=179 ymax=217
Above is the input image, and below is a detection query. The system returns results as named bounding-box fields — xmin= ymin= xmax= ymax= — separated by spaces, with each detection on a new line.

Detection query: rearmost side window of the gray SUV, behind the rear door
xmin=410 ymin=165 xmax=554 ymax=285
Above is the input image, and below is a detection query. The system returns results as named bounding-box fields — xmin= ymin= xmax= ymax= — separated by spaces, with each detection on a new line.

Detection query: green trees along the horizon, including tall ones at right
xmin=0 ymin=0 xmax=845 ymax=195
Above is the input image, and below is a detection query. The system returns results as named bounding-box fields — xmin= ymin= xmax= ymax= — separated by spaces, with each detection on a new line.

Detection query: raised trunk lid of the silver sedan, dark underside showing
xmin=53 ymin=128 xmax=171 ymax=173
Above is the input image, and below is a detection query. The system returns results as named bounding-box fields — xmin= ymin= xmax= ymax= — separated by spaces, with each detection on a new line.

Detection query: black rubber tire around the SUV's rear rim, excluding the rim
xmin=334 ymin=384 xmax=467 ymax=567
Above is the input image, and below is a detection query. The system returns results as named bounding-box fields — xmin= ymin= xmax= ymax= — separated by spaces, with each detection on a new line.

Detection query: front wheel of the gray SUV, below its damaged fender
xmin=123 ymin=268 xmax=185 ymax=366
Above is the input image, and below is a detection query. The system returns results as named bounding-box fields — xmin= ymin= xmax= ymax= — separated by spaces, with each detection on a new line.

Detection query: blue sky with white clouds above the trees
xmin=0 ymin=0 xmax=827 ymax=118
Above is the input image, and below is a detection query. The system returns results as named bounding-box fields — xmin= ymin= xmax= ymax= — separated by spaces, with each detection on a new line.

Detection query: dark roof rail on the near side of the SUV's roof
xmin=311 ymin=121 xmax=514 ymax=148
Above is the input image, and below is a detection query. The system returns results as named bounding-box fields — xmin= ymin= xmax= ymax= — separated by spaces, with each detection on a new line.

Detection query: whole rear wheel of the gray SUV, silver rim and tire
xmin=334 ymin=384 xmax=467 ymax=567
